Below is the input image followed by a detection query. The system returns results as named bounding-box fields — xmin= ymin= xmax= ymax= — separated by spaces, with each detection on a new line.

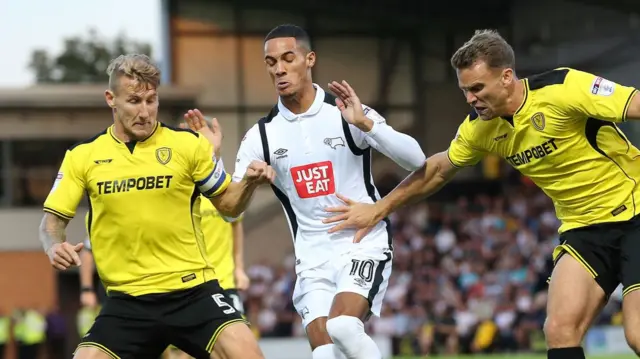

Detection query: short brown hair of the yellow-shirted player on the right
xmin=451 ymin=30 xmax=516 ymax=70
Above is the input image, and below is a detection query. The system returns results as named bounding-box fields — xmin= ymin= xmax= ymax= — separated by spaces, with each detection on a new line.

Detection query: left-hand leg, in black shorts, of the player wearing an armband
xmin=73 ymin=297 xmax=167 ymax=359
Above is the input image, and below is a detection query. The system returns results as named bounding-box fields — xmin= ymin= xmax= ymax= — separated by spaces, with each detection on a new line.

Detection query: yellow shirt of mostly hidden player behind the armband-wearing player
xmin=200 ymin=200 xmax=240 ymax=289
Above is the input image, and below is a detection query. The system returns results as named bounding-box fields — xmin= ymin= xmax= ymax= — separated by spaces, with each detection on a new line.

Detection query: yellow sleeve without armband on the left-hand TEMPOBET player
xmin=44 ymin=151 xmax=85 ymax=219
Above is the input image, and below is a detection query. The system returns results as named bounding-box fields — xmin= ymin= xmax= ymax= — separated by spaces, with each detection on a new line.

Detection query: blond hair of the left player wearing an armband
xmin=107 ymin=54 xmax=160 ymax=91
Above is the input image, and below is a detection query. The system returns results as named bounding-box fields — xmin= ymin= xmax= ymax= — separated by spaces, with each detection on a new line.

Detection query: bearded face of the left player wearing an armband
xmin=106 ymin=76 xmax=158 ymax=141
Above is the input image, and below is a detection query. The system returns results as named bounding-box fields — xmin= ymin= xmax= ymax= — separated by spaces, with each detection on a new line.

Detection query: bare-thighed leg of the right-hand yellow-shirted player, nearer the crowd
xmin=544 ymin=231 xmax=619 ymax=359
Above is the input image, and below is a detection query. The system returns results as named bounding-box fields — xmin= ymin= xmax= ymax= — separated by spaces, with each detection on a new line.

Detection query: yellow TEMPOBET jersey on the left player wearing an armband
xmin=44 ymin=124 xmax=231 ymax=295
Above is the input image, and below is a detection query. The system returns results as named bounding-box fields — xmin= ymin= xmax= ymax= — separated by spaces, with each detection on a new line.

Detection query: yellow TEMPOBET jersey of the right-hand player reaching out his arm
xmin=448 ymin=68 xmax=640 ymax=232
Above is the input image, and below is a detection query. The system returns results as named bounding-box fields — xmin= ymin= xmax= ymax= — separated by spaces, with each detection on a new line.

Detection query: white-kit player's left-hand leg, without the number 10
xmin=293 ymin=272 xmax=343 ymax=359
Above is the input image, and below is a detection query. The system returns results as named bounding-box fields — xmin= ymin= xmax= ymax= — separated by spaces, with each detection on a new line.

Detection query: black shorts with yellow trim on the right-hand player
xmin=553 ymin=216 xmax=640 ymax=298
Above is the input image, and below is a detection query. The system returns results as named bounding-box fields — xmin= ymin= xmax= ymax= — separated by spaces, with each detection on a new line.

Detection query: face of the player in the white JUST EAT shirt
xmin=264 ymin=37 xmax=316 ymax=97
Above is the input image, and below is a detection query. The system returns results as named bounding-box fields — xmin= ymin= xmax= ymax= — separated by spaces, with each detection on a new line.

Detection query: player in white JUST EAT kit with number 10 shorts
xmin=185 ymin=25 xmax=426 ymax=359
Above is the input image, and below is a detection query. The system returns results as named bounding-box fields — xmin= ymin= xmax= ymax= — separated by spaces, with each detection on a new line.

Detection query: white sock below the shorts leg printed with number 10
xmin=327 ymin=315 xmax=382 ymax=359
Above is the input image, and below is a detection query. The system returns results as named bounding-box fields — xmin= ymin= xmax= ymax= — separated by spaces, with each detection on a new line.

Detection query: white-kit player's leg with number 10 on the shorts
xmin=327 ymin=250 xmax=392 ymax=359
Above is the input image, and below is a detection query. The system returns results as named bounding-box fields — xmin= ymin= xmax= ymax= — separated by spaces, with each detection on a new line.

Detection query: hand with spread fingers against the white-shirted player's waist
xmin=322 ymin=194 xmax=382 ymax=243
